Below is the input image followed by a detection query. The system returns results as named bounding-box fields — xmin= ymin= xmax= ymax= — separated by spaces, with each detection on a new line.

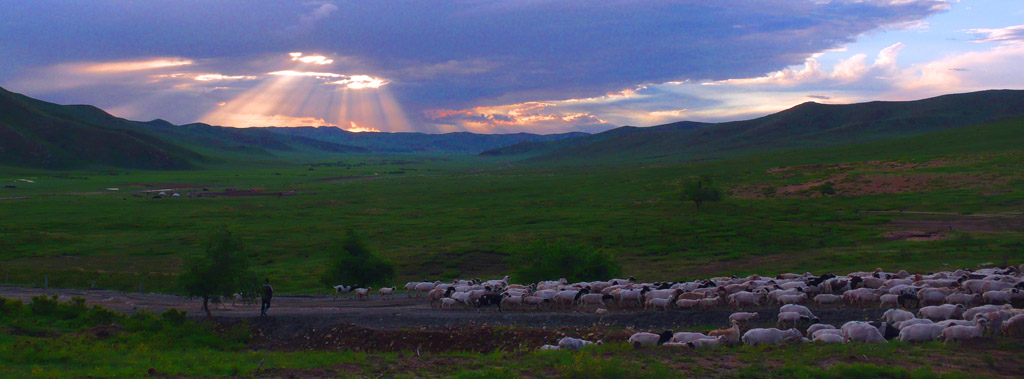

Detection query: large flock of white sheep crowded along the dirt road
xmin=385 ymin=265 xmax=1024 ymax=349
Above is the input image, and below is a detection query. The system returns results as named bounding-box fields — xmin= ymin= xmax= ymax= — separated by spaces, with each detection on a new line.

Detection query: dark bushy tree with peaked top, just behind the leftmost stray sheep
xmin=321 ymin=230 xmax=394 ymax=286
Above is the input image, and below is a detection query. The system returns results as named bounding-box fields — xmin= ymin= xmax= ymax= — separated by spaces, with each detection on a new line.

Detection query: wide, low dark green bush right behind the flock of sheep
xmin=509 ymin=241 xmax=622 ymax=283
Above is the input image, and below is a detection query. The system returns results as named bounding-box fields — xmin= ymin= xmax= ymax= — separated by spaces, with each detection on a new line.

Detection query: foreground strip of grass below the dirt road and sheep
xmin=0 ymin=297 xmax=1024 ymax=378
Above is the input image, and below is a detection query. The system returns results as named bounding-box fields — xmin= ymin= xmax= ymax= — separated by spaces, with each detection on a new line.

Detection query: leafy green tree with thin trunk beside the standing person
xmin=178 ymin=229 xmax=259 ymax=317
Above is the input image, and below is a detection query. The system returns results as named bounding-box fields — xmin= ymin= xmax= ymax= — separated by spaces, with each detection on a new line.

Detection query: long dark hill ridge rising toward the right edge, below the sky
xmin=481 ymin=90 xmax=1024 ymax=162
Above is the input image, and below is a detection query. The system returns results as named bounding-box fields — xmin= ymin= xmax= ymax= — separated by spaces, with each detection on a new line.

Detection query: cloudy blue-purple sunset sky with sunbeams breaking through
xmin=0 ymin=0 xmax=1024 ymax=134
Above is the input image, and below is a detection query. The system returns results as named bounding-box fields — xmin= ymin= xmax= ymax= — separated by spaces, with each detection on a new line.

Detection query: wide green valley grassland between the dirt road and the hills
xmin=0 ymin=119 xmax=1024 ymax=293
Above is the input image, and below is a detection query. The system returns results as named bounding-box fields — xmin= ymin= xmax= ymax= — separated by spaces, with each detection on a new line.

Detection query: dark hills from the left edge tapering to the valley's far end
xmin=0 ymin=88 xmax=585 ymax=169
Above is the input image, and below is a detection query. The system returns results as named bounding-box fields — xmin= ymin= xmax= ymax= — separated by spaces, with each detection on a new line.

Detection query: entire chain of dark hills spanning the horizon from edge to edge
xmin=0 ymin=88 xmax=1024 ymax=169
